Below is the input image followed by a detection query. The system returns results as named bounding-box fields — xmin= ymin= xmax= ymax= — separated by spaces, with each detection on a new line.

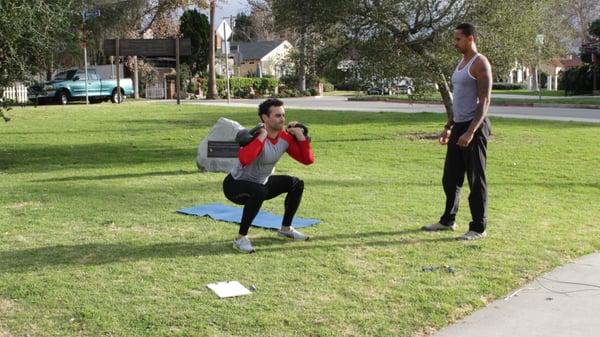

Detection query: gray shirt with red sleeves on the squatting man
xmin=230 ymin=130 xmax=315 ymax=185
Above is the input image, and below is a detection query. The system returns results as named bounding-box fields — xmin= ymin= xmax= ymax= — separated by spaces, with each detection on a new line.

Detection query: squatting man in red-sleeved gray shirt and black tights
xmin=223 ymin=98 xmax=314 ymax=253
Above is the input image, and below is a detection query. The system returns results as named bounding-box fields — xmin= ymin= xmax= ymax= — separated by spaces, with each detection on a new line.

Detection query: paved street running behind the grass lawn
xmin=163 ymin=96 xmax=600 ymax=123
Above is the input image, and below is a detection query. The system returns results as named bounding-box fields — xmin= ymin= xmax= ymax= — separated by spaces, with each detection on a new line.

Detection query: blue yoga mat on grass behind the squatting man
xmin=177 ymin=204 xmax=321 ymax=229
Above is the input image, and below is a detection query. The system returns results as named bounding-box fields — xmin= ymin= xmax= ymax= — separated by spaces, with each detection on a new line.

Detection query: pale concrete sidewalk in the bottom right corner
xmin=432 ymin=253 xmax=600 ymax=337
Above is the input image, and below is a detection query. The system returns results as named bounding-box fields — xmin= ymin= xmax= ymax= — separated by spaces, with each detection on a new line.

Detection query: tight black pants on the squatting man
xmin=223 ymin=174 xmax=304 ymax=235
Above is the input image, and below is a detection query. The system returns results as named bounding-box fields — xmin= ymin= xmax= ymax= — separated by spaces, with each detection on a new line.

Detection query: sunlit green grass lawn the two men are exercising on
xmin=0 ymin=103 xmax=600 ymax=336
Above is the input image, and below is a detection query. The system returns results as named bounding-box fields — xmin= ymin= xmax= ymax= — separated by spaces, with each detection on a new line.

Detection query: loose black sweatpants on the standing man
xmin=440 ymin=118 xmax=491 ymax=233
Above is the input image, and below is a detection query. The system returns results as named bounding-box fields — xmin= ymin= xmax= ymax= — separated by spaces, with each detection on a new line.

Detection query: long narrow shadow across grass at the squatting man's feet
xmin=0 ymin=230 xmax=455 ymax=273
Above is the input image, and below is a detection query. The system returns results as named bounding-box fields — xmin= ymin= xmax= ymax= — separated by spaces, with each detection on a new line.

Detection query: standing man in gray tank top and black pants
xmin=422 ymin=23 xmax=492 ymax=240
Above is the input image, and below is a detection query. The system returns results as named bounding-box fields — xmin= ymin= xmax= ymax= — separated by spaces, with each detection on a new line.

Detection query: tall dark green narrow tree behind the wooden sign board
xmin=179 ymin=9 xmax=210 ymax=75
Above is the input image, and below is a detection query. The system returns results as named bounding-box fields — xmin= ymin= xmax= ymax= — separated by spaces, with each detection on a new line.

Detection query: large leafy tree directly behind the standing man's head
xmin=348 ymin=0 xmax=564 ymax=111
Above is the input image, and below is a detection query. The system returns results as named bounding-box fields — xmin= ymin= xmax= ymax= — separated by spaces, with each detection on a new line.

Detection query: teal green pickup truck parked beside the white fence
xmin=28 ymin=68 xmax=133 ymax=104
